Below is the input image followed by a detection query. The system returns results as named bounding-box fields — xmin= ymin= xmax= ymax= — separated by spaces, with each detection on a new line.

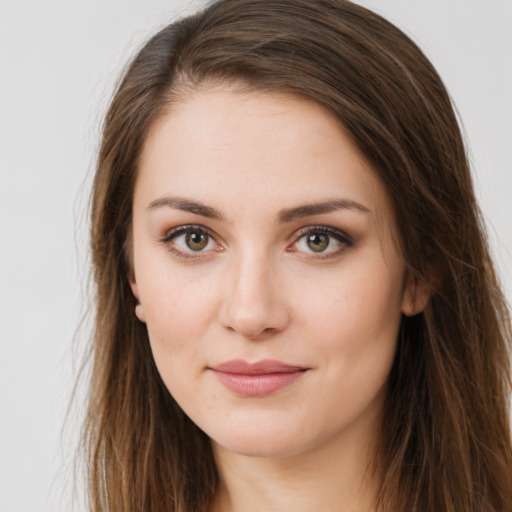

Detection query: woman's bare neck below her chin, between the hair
xmin=208 ymin=412 xmax=376 ymax=512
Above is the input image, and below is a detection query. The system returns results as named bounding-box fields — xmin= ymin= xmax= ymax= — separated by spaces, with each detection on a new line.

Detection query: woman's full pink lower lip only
xmin=213 ymin=370 xmax=306 ymax=397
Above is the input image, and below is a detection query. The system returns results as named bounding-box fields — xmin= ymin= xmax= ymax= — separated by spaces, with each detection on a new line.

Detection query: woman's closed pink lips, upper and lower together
xmin=209 ymin=359 xmax=309 ymax=397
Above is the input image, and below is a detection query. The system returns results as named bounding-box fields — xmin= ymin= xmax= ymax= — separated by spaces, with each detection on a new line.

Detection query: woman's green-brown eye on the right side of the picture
xmin=289 ymin=226 xmax=354 ymax=258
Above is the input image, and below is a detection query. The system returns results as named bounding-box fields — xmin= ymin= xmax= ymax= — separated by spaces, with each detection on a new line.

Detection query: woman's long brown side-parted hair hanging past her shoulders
xmin=84 ymin=0 xmax=512 ymax=512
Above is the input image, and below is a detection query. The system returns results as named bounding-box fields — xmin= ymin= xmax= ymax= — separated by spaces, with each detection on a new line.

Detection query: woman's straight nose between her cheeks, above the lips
xmin=219 ymin=251 xmax=290 ymax=341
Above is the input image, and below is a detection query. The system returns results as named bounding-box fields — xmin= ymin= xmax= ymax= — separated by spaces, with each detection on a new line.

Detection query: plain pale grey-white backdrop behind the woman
xmin=0 ymin=0 xmax=512 ymax=512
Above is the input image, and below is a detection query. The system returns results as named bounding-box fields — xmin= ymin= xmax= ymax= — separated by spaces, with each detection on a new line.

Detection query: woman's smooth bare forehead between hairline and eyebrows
xmin=135 ymin=87 xmax=389 ymax=222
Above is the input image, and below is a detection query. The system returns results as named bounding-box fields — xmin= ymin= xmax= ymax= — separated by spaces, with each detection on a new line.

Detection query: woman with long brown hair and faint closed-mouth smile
xmin=85 ymin=0 xmax=512 ymax=512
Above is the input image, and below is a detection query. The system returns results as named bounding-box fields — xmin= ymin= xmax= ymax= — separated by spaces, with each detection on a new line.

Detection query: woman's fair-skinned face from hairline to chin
xmin=130 ymin=88 xmax=413 ymax=457
